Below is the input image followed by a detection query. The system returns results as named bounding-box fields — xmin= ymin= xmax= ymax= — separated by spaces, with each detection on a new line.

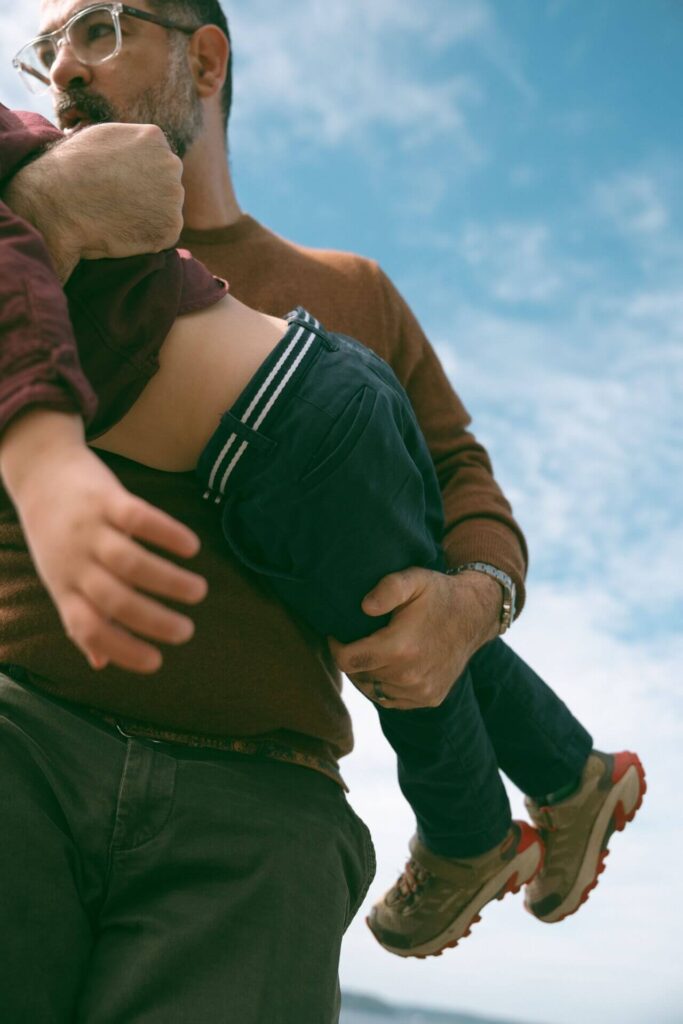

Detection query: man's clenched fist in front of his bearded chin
xmin=3 ymin=124 xmax=184 ymax=282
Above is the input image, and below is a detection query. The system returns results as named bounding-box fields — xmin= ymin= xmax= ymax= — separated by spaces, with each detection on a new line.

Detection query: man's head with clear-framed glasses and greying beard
xmin=34 ymin=0 xmax=231 ymax=157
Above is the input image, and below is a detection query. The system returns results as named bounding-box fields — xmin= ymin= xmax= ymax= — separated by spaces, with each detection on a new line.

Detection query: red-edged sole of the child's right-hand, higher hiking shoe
xmin=525 ymin=751 xmax=647 ymax=925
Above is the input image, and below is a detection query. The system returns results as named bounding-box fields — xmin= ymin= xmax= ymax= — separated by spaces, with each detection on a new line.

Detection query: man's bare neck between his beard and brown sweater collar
xmin=182 ymin=132 xmax=242 ymax=230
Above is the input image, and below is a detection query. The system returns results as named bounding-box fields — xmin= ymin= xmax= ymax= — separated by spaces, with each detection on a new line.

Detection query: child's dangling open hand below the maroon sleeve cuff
xmin=0 ymin=410 xmax=207 ymax=673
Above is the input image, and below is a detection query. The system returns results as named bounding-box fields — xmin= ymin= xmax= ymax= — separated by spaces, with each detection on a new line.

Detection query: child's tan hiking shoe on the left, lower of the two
xmin=367 ymin=821 xmax=543 ymax=957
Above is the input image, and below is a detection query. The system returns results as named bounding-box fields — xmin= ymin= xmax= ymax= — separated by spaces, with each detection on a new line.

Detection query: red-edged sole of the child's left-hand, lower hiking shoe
xmin=366 ymin=821 xmax=545 ymax=959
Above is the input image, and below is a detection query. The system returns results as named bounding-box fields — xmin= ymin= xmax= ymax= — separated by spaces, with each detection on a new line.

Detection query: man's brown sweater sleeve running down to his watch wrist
xmin=377 ymin=268 xmax=527 ymax=612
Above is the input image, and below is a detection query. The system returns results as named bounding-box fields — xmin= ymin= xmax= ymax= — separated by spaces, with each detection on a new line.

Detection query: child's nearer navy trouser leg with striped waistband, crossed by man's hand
xmin=199 ymin=311 xmax=518 ymax=856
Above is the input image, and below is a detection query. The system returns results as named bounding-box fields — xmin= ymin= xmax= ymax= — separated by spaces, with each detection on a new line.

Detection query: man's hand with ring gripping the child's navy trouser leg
xmin=330 ymin=568 xmax=503 ymax=711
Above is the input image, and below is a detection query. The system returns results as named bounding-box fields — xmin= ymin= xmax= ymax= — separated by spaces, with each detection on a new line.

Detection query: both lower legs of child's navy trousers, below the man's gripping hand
xmin=378 ymin=639 xmax=593 ymax=857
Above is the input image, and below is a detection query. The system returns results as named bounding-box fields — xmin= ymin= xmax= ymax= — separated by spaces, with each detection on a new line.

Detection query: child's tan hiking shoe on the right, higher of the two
xmin=524 ymin=751 xmax=646 ymax=924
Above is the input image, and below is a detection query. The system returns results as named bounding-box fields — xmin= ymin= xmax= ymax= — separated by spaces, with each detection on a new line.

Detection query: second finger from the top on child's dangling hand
xmin=95 ymin=529 xmax=207 ymax=604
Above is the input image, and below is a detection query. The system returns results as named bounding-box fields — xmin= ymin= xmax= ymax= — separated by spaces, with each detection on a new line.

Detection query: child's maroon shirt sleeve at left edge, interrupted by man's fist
xmin=0 ymin=104 xmax=97 ymax=431
